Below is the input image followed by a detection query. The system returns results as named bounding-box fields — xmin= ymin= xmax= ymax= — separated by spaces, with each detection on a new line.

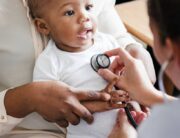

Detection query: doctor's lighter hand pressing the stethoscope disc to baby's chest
xmin=98 ymin=48 xmax=156 ymax=106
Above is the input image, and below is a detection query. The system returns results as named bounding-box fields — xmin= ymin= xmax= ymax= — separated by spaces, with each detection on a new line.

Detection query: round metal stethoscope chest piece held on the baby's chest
xmin=91 ymin=54 xmax=111 ymax=72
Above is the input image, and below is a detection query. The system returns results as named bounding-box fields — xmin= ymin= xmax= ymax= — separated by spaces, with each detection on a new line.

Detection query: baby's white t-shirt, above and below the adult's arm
xmin=33 ymin=33 xmax=119 ymax=138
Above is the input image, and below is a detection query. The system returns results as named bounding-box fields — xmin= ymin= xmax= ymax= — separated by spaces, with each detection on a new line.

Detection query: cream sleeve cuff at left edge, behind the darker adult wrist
xmin=0 ymin=90 xmax=22 ymax=136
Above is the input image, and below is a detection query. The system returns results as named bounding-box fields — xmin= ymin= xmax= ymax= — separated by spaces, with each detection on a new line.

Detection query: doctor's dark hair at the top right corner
xmin=148 ymin=0 xmax=180 ymax=44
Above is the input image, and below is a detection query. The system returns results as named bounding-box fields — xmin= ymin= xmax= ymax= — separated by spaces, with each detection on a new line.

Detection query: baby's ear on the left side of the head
xmin=34 ymin=18 xmax=50 ymax=36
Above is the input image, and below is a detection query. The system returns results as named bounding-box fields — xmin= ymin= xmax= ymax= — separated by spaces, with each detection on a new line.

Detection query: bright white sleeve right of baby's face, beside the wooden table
xmin=98 ymin=0 xmax=141 ymax=48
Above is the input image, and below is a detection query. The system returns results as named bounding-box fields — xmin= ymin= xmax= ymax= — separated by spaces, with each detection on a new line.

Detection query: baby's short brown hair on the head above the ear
xmin=26 ymin=0 xmax=48 ymax=19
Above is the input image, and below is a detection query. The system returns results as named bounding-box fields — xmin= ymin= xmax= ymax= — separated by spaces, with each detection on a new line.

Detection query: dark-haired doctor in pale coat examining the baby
xmin=99 ymin=0 xmax=180 ymax=138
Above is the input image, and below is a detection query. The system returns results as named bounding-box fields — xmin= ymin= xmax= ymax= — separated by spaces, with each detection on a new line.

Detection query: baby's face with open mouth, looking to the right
xmin=43 ymin=0 xmax=96 ymax=52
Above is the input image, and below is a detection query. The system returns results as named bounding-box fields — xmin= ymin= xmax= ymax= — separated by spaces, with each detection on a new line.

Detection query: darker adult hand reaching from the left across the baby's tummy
xmin=5 ymin=81 xmax=110 ymax=127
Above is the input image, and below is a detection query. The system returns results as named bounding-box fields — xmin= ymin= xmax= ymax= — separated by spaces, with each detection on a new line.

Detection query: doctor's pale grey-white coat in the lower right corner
xmin=138 ymin=100 xmax=180 ymax=138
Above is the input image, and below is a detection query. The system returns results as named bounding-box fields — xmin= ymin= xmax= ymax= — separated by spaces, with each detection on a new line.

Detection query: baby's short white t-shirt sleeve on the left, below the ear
xmin=33 ymin=51 xmax=59 ymax=81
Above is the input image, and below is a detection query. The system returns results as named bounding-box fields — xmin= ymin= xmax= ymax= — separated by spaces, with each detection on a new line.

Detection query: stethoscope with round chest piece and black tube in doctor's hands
xmin=91 ymin=54 xmax=138 ymax=128
